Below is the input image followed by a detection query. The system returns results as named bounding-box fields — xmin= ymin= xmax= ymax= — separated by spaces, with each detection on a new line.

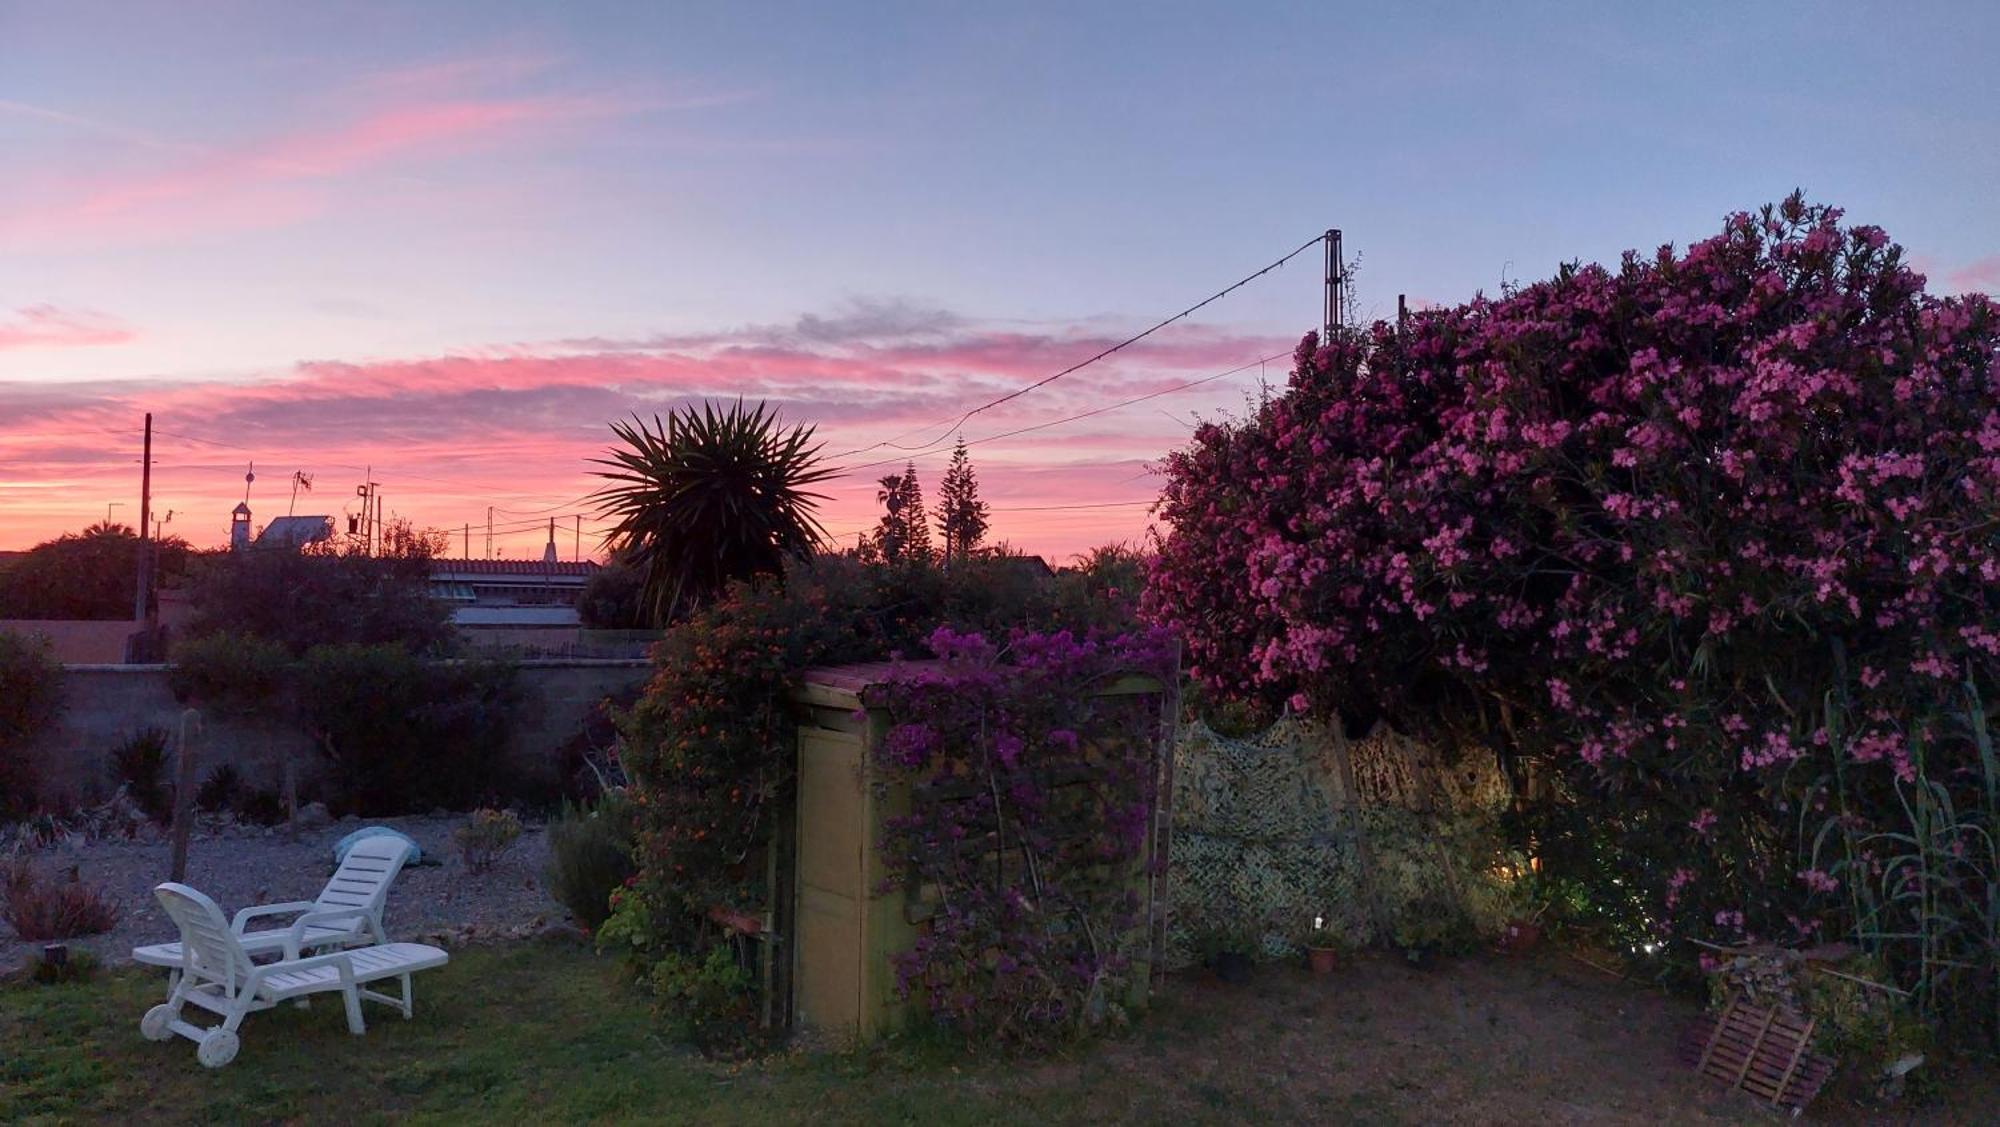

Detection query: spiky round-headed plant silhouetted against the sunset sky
xmin=594 ymin=400 xmax=838 ymax=625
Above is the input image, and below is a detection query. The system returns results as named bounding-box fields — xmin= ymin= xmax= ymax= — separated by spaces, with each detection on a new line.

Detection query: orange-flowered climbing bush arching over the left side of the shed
xmin=600 ymin=556 xmax=1132 ymax=1055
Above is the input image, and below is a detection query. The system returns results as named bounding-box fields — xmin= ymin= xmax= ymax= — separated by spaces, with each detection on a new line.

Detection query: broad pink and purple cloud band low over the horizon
xmin=0 ymin=308 xmax=1292 ymax=558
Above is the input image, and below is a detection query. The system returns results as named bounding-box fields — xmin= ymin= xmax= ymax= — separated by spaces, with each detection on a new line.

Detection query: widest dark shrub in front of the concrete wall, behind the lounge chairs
xmin=296 ymin=645 xmax=520 ymax=815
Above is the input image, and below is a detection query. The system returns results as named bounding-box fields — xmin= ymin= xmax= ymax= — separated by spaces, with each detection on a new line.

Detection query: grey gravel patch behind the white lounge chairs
xmin=0 ymin=815 xmax=568 ymax=971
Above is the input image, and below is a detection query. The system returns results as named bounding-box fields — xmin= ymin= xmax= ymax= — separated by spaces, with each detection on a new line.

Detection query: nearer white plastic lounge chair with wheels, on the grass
xmin=138 ymin=883 xmax=450 ymax=1069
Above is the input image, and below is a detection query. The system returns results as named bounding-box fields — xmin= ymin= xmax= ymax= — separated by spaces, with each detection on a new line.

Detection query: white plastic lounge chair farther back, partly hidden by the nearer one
xmin=132 ymin=833 xmax=410 ymax=971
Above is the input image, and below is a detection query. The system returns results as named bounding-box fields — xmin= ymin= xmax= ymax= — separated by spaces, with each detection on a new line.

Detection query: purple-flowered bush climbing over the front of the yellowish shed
xmin=866 ymin=627 xmax=1176 ymax=1047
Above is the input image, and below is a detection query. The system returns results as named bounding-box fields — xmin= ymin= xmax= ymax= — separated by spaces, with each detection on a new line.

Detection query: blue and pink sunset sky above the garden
xmin=0 ymin=0 xmax=2000 ymax=560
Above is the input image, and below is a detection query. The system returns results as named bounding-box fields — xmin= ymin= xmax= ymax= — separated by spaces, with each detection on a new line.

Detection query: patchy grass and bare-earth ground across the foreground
xmin=0 ymin=943 xmax=1984 ymax=1123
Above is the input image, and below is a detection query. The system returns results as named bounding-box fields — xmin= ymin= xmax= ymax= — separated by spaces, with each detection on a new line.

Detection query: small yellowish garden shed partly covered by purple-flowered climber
xmin=790 ymin=661 xmax=1172 ymax=1041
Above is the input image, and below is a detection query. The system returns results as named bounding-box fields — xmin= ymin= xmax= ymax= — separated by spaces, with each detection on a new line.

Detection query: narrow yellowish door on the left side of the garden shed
xmin=794 ymin=727 xmax=868 ymax=1035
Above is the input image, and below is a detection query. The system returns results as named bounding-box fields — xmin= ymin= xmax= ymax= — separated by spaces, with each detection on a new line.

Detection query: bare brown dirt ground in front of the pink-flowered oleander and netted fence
xmin=1016 ymin=949 xmax=1994 ymax=1123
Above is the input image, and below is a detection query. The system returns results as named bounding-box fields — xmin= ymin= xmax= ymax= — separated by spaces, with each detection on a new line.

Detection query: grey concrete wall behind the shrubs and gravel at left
xmin=32 ymin=659 xmax=648 ymax=801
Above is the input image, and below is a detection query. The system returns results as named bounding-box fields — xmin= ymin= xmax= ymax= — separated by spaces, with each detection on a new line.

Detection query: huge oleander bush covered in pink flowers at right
xmin=1148 ymin=196 xmax=2000 ymax=1029
